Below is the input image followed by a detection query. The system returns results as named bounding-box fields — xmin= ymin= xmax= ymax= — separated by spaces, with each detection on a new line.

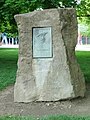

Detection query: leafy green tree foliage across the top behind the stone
xmin=0 ymin=0 xmax=90 ymax=33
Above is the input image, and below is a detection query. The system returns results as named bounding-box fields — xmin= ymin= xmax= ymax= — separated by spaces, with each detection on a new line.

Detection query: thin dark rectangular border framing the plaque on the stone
xmin=32 ymin=26 xmax=53 ymax=59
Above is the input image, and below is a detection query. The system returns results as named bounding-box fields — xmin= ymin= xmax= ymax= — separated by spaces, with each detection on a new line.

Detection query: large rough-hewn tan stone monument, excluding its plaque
xmin=14 ymin=9 xmax=85 ymax=102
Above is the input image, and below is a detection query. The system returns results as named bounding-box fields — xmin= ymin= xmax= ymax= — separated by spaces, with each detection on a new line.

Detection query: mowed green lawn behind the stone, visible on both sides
xmin=0 ymin=48 xmax=90 ymax=90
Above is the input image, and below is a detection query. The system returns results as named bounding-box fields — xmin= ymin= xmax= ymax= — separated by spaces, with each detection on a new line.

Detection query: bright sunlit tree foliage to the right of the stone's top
xmin=77 ymin=0 xmax=90 ymax=36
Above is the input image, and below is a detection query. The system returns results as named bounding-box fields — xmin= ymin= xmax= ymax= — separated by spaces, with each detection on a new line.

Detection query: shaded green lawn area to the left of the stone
xmin=0 ymin=48 xmax=18 ymax=90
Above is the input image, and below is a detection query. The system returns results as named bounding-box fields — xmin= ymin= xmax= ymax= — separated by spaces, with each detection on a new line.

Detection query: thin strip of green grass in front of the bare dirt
xmin=0 ymin=115 xmax=90 ymax=120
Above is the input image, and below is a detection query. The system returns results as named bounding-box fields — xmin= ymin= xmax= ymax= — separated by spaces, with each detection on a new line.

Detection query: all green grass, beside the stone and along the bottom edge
xmin=0 ymin=48 xmax=90 ymax=120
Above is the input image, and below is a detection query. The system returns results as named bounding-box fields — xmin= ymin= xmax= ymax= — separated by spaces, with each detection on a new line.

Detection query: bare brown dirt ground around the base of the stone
xmin=0 ymin=84 xmax=90 ymax=117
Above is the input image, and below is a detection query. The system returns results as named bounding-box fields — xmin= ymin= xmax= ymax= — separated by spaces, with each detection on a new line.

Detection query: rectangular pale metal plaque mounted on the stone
xmin=32 ymin=27 xmax=53 ymax=58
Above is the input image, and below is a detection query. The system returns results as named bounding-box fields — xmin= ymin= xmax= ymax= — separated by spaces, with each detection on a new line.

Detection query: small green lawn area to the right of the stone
xmin=76 ymin=51 xmax=90 ymax=82
